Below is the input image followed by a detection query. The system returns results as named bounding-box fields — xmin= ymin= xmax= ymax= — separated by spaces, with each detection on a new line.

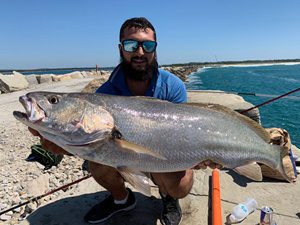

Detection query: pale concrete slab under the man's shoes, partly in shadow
xmin=20 ymin=169 xmax=300 ymax=225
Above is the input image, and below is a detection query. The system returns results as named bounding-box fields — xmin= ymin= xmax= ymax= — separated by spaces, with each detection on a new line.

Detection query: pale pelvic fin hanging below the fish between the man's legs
xmin=117 ymin=166 xmax=151 ymax=197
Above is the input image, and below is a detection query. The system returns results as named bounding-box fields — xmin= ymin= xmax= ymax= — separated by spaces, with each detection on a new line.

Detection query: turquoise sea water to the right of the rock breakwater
xmin=186 ymin=64 xmax=300 ymax=147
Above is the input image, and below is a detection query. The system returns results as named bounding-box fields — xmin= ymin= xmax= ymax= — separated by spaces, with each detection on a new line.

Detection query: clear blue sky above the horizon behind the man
xmin=0 ymin=0 xmax=300 ymax=69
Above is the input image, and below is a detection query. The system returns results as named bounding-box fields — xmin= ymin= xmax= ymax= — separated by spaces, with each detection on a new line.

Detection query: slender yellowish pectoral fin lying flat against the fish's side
xmin=114 ymin=139 xmax=166 ymax=160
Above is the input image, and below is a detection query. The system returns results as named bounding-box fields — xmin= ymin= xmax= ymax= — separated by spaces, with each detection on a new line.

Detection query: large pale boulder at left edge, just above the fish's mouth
xmin=0 ymin=71 xmax=29 ymax=93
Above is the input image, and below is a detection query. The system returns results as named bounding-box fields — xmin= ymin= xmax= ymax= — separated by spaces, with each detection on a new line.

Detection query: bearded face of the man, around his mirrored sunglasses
xmin=119 ymin=27 xmax=156 ymax=78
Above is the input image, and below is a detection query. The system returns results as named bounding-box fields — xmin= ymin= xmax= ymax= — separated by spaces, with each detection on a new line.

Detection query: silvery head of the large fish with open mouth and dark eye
xmin=14 ymin=92 xmax=114 ymax=146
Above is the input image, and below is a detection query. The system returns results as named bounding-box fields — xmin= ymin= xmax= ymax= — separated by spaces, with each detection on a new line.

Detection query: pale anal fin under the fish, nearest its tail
xmin=233 ymin=162 xmax=262 ymax=181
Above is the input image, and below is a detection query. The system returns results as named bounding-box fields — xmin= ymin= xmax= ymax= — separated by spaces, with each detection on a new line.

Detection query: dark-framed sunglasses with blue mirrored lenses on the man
xmin=122 ymin=39 xmax=157 ymax=53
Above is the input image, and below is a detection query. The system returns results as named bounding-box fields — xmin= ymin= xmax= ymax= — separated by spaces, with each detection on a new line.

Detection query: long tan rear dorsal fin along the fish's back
xmin=186 ymin=102 xmax=271 ymax=143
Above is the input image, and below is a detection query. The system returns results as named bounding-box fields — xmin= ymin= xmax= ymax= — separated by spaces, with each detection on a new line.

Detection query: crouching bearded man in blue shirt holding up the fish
xmin=31 ymin=18 xmax=218 ymax=225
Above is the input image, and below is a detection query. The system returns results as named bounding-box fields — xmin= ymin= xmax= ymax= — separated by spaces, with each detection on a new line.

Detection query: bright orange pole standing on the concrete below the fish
xmin=212 ymin=169 xmax=222 ymax=225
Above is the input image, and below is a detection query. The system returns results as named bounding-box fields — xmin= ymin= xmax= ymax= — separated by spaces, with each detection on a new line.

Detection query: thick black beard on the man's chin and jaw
xmin=121 ymin=54 xmax=158 ymax=81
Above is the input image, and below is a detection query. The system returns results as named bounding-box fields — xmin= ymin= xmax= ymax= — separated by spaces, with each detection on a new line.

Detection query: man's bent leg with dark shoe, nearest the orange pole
xmin=151 ymin=170 xmax=193 ymax=225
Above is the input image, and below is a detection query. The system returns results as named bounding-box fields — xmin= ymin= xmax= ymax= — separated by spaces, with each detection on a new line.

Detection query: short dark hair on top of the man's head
xmin=120 ymin=17 xmax=156 ymax=42
